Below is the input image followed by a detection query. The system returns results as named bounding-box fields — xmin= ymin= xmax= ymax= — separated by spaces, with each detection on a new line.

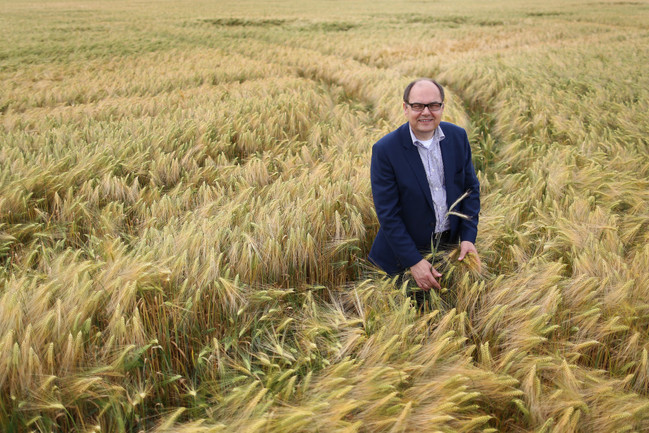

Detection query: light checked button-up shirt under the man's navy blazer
xmin=410 ymin=126 xmax=451 ymax=233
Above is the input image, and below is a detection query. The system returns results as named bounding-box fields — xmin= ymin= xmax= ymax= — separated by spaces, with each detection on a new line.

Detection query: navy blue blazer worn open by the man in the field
xmin=369 ymin=122 xmax=480 ymax=275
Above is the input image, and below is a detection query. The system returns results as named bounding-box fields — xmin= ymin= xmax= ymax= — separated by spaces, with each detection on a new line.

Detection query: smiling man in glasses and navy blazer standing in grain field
xmin=369 ymin=78 xmax=480 ymax=291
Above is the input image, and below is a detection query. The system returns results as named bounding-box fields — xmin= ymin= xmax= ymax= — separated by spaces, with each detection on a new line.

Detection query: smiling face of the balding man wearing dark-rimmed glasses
xmin=403 ymin=81 xmax=444 ymax=140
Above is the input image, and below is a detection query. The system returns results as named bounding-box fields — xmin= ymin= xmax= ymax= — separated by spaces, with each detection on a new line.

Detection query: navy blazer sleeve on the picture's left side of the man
xmin=370 ymin=142 xmax=423 ymax=268
